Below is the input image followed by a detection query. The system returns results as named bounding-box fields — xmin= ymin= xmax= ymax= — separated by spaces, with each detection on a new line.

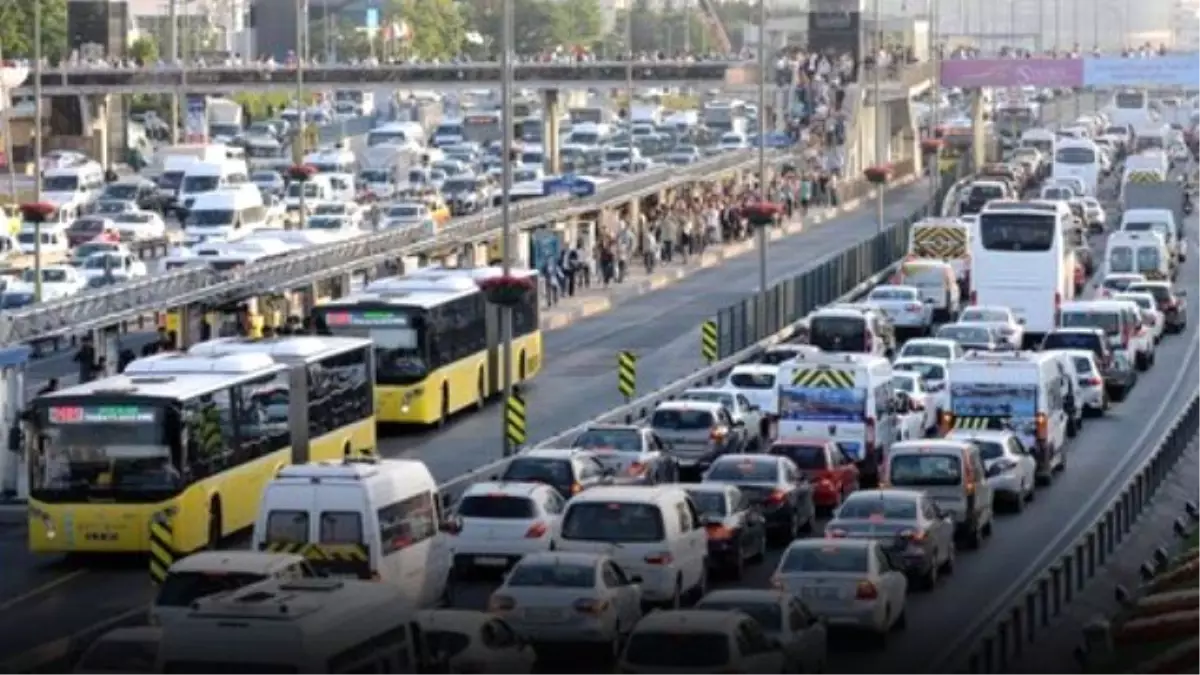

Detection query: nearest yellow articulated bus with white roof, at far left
xmin=25 ymin=336 xmax=376 ymax=554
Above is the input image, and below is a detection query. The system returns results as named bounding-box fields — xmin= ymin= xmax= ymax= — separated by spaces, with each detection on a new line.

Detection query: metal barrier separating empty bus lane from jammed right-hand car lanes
xmin=438 ymin=159 xmax=956 ymax=502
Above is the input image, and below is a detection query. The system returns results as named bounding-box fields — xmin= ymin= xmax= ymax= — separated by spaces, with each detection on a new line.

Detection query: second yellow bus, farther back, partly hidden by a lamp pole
xmin=313 ymin=268 xmax=542 ymax=425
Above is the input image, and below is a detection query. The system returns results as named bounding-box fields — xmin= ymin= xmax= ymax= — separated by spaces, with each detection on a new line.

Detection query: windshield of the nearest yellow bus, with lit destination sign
xmin=31 ymin=400 xmax=182 ymax=501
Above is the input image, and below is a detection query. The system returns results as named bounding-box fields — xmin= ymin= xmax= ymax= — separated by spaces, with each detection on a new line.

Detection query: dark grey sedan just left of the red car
xmin=702 ymin=454 xmax=816 ymax=544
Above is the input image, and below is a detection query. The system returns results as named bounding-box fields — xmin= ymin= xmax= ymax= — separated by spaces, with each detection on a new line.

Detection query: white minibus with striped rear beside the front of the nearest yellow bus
xmin=251 ymin=456 xmax=453 ymax=608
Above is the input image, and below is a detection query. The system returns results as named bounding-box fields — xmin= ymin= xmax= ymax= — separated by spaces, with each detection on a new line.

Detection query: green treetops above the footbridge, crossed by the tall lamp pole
xmin=467 ymin=0 xmax=604 ymax=55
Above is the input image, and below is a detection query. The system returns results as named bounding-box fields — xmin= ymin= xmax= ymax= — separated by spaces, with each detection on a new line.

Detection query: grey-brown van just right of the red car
xmin=886 ymin=438 xmax=996 ymax=548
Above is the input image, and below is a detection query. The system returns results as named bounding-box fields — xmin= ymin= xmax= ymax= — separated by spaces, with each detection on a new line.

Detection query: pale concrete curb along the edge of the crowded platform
xmin=540 ymin=174 xmax=924 ymax=330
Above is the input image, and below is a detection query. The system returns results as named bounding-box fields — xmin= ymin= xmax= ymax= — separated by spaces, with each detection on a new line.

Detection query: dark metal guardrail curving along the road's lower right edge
xmin=929 ymin=372 xmax=1200 ymax=675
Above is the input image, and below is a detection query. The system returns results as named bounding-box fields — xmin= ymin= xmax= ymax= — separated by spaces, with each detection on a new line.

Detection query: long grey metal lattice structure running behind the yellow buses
xmin=0 ymin=150 xmax=781 ymax=345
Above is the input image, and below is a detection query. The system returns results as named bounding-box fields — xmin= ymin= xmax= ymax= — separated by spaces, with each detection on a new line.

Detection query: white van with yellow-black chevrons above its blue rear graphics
xmin=776 ymin=353 xmax=896 ymax=485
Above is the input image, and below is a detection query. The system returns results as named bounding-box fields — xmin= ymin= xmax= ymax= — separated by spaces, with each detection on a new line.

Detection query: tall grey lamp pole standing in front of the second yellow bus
xmin=498 ymin=0 xmax=516 ymax=456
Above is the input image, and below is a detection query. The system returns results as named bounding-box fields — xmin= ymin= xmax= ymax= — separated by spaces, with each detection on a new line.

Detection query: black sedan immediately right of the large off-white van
xmin=686 ymin=483 xmax=767 ymax=579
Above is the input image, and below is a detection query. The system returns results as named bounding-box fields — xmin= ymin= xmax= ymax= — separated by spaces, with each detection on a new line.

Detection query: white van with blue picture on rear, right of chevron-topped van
xmin=941 ymin=348 xmax=1070 ymax=483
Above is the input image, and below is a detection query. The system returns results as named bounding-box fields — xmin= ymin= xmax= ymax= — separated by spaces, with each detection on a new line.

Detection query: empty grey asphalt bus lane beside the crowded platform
xmin=393 ymin=181 xmax=929 ymax=480
